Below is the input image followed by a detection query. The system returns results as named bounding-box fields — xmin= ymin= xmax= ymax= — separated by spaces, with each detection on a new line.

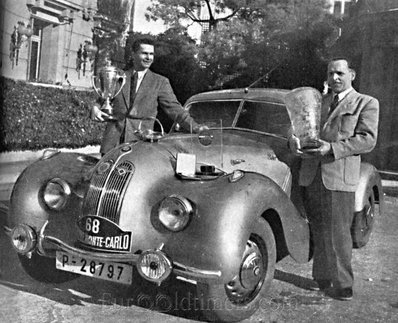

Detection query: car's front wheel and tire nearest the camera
xmin=197 ymin=219 xmax=276 ymax=322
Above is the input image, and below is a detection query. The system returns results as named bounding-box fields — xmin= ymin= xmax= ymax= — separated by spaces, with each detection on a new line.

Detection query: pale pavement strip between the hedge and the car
xmin=0 ymin=146 xmax=100 ymax=201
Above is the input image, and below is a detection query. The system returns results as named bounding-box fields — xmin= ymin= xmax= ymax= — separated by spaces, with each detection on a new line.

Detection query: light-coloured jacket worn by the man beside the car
xmin=299 ymin=89 xmax=379 ymax=192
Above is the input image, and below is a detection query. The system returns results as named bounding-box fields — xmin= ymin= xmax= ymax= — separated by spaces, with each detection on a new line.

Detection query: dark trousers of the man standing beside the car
xmin=303 ymin=169 xmax=355 ymax=288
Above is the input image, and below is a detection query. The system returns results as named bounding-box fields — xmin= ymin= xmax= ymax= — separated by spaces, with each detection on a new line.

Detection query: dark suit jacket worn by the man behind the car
xmin=101 ymin=70 xmax=197 ymax=153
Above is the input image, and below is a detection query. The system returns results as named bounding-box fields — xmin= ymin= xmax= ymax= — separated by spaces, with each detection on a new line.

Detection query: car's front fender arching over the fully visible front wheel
xmin=165 ymin=172 xmax=310 ymax=282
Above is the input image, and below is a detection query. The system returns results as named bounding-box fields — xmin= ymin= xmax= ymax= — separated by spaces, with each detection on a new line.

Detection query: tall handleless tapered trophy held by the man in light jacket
xmin=285 ymin=87 xmax=322 ymax=151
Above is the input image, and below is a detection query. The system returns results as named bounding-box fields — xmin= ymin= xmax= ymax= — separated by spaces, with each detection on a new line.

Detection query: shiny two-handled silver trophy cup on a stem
xmin=91 ymin=65 xmax=126 ymax=120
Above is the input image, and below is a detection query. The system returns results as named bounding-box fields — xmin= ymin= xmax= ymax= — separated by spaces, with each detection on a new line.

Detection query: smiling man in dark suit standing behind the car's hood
xmin=91 ymin=38 xmax=200 ymax=154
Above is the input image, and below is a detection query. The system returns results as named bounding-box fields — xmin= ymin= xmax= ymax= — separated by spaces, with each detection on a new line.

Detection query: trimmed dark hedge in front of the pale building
xmin=0 ymin=77 xmax=104 ymax=152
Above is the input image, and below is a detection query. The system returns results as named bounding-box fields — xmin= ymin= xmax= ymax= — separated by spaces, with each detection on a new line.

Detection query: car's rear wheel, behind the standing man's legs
xmin=351 ymin=189 xmax=376 ymax=249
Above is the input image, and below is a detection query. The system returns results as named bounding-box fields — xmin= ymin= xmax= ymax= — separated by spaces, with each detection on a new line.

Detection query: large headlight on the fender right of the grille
xmin=158 ymin=195 xmax=193 ymax=231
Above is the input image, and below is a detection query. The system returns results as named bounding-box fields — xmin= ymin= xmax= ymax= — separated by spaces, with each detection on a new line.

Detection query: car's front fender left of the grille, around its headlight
xmin=7 ymin=151 xmax=97 ymax=231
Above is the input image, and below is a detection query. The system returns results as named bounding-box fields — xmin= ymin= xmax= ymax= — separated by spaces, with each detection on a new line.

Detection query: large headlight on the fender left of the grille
xmin=43 ymin=178 xmax=72 ymax=210
